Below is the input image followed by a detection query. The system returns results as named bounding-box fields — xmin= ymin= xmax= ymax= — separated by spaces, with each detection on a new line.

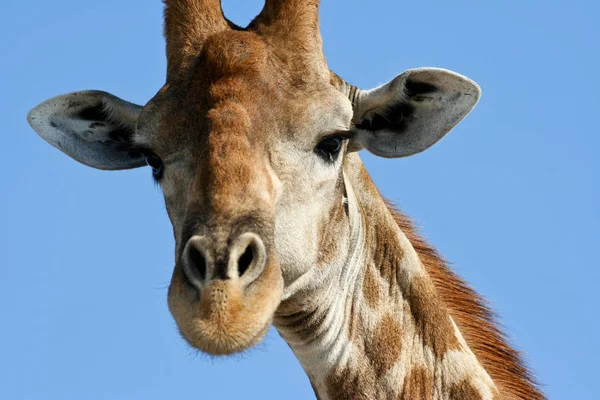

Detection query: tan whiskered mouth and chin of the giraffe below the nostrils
xmin=169 ymin=266 xmax=283 ymax=355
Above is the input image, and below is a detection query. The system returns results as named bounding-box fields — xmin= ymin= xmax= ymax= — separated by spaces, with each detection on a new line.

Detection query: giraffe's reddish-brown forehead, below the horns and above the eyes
xmin=137 ymin=31 xmax=352 ymax=152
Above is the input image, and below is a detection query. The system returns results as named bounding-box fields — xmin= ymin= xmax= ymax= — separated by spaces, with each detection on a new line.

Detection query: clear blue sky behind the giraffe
xmin=0 ymin=0 xmax=600 ymax=400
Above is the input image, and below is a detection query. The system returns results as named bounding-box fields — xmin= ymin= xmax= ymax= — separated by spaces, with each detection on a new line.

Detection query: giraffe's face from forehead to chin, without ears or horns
xmin=131 ymin=31 xmax=352 ymax=354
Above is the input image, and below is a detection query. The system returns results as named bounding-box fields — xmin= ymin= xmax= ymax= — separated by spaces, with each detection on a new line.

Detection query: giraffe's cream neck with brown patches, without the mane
xmin=274 ymin=155 xmax=497 ymax=400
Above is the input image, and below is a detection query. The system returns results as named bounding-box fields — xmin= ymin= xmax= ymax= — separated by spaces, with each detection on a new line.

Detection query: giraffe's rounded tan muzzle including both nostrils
xmin=169 ymin=232 xmax=283 ymax=355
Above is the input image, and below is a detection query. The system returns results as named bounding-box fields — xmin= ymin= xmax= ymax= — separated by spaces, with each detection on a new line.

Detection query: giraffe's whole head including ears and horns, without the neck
xmin=28 ymin=0 xmax=479 ymax=354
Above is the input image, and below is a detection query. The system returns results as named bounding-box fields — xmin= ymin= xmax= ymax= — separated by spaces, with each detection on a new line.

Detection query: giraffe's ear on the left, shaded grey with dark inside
xmin=27 ymin=90 xmax=145 ymax=170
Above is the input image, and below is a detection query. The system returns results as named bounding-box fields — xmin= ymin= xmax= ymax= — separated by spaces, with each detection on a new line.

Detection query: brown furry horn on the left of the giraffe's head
xmin=164 ymin=0 xmax=232 ymax=76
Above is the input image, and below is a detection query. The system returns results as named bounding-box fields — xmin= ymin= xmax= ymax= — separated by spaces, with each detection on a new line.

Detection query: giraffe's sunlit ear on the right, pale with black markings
xmin=352 ymin=68 xmax=481 ymax=158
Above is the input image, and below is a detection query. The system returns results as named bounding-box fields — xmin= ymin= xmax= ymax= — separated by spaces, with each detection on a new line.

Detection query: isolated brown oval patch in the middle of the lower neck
xmin=365 ymin=314 xmax=402 ymax=377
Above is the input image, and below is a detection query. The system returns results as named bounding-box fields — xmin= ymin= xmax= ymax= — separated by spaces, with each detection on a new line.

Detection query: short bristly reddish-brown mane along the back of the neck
xmin=386 ymin=200 xmax=545 ymax=400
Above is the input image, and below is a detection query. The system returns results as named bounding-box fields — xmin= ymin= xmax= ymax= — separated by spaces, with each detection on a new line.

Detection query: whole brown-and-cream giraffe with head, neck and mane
xmin=28 ymin=0 xmax=544 ymax=400
